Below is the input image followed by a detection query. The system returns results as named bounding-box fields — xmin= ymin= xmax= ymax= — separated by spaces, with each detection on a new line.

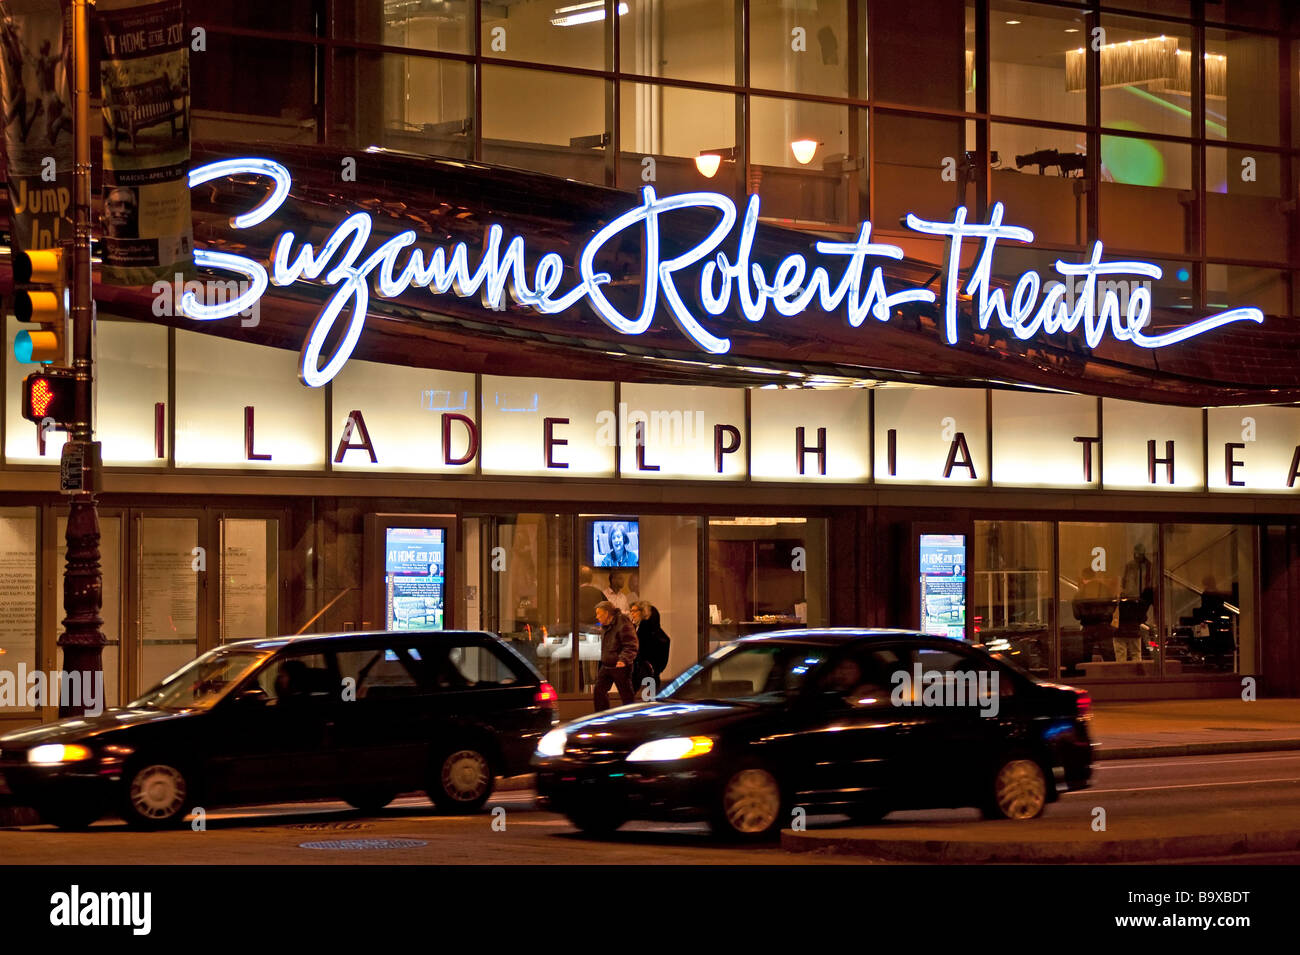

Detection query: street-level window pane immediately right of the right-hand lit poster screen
xmin=971 ymin=521 xmax=1054 ymax=677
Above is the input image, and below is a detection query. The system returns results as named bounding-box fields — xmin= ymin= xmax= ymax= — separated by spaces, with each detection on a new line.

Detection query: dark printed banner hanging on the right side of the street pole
xmin=96 ymin=0 xmax=194 ymax=285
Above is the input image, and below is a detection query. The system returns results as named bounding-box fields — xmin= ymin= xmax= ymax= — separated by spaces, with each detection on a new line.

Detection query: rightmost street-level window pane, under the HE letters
xmin=1164 ymin=524 xmax=1258 ymax=676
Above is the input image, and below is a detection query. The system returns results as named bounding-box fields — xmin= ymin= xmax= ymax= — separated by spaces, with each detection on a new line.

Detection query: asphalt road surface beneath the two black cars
xmin=0 ymin=752 xmax=1300 ymax=865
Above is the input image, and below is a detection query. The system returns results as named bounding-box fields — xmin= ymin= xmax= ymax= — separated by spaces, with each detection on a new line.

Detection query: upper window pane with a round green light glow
xmin=1099 ymin=136 xmax=1196 ymax=253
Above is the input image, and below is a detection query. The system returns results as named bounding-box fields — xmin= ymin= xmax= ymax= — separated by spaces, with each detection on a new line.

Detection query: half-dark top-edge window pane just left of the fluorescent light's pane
xmin=335 ymin=0 xmax=472 ymax=53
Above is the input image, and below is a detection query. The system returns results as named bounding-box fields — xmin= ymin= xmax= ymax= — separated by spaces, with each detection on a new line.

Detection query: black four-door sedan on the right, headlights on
xmin=533 ymin=630 xmax=1092 ymax=839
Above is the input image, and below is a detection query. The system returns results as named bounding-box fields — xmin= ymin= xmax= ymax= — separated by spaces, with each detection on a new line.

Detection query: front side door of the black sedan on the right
xmin=774 ymin=643 xmax=902 ymax=808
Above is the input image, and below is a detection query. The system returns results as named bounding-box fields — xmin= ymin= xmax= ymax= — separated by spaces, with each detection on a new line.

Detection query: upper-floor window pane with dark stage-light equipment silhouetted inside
xmin=989 ymin=123 xmax=1088 ymax=248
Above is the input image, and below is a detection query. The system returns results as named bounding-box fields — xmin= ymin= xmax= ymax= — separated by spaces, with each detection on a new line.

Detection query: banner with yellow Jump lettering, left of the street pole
xmin=0 ymin=0 xmax=73 ymax=249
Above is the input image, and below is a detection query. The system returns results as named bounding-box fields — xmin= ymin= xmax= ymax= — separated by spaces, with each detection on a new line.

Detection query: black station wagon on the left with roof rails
xmin=0 ymin=631 xmax=558 ymax=828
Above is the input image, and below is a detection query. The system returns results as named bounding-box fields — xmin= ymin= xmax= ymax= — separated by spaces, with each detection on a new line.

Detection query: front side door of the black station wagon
xmin=208 ymin=647 xmax=341 ymax=802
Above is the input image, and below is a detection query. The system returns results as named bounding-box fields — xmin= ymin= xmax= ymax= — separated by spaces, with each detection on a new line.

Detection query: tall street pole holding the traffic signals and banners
xmin=59 ymin=0 xmax=105 ymax=716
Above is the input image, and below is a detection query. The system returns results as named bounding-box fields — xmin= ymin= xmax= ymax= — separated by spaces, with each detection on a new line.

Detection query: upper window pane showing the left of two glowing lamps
xmin=619 ymin=83 xmax=742 ymax=195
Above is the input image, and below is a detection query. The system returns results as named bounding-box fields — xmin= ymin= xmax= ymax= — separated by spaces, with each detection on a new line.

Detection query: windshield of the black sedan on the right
xmin=659 ymin=642 xmax=828 ymax=703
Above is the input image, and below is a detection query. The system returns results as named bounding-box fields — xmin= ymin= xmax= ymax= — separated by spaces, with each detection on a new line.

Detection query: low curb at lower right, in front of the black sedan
xmin=781 ymin=829 xmax=1300 ymax=864
